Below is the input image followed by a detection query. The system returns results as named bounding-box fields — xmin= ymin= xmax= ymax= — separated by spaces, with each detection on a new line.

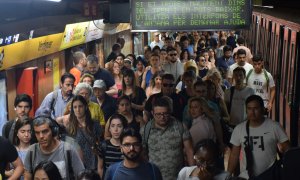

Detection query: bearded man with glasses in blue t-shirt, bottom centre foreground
xmin=104 ymin=128 xmax=162 ymax=180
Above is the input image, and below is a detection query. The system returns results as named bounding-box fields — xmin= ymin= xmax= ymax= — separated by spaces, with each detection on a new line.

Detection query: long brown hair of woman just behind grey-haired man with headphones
xmin=68 ymin=95 xmax=94 ymax=135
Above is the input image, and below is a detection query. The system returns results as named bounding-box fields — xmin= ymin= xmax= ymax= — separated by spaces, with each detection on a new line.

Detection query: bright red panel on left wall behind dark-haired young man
xmin=16 ymin=67 xmax=38 ymax=117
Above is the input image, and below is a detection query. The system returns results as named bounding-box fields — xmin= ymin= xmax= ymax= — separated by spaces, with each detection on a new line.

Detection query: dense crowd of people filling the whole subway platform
xmin=0 ymin=31 xmax=289 ymax=180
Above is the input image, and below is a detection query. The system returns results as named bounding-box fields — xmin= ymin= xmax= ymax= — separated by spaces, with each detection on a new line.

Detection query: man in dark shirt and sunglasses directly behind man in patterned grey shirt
xmin=143 ymin=74 xmax=186 ymax=122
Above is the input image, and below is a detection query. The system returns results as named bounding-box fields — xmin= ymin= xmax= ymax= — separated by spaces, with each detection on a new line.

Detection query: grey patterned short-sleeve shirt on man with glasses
xmin=141 ymin=118 xmax=191 ymax=180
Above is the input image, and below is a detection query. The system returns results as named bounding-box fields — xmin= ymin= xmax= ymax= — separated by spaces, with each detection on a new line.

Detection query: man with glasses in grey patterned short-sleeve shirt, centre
xmin=141 ymin=96 xmax=194 ymax=180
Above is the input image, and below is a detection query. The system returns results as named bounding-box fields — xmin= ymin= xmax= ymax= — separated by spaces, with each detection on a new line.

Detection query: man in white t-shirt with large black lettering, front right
xmin=228 ymin=95 xmax=289 ymax=179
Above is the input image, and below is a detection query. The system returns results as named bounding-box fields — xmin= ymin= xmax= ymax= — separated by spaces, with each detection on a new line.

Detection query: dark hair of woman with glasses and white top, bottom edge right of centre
xmin=194 ymin=139 xmax=219 ymax=161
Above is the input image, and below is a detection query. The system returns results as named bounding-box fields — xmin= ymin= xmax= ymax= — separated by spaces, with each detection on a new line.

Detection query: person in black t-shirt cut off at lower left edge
xmin=0 ymin=136 xmax=24 ymax=179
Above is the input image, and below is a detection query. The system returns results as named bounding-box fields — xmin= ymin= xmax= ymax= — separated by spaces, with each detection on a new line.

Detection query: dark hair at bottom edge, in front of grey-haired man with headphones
xmin=33 ymin=161 xmax=62 ymax=180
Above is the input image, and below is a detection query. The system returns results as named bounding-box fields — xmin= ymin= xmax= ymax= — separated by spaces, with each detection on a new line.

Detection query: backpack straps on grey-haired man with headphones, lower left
xmin=29 ymin=142 xmax=76 ymax=179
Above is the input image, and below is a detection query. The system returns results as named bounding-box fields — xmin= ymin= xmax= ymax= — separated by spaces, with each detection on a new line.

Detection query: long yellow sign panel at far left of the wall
xmin=0 ymin=33 xmax=63 ymax=70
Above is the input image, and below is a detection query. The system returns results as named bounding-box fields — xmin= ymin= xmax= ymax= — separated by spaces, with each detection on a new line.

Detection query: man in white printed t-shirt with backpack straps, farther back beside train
xmin=246 ymin=54 xmax=275 ymax=112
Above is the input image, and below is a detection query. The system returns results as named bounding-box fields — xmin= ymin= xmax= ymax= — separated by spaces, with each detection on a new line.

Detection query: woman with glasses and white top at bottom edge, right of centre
xmin=177 ymin=139 xmax=229 ymax=180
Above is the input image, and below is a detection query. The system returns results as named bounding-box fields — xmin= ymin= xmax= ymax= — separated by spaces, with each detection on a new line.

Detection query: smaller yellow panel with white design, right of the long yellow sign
xmin=60 ymin=22 xmax=89 ymax=50
